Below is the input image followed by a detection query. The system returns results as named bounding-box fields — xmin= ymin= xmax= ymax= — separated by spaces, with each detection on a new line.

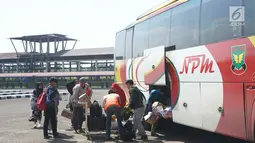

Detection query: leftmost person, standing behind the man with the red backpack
xmin=29 ymin=82 xmax=43 ymax=128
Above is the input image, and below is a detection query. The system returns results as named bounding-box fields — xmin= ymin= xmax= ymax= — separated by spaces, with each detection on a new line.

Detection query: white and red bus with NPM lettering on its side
xmin=115 ymin=0 xmax=255 ymax=141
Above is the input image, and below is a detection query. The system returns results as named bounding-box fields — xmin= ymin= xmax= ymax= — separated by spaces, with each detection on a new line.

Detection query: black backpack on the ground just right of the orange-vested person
xmin=120 ymin=121 xmax=135 ymax=142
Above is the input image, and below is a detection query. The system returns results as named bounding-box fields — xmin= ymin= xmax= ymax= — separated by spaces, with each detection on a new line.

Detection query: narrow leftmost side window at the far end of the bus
xmin=114 ymin=30 xmax=126 ymax=60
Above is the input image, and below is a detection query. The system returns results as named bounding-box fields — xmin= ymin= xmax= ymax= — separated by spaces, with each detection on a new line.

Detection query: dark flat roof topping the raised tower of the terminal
xmin=9 ymin=34 xmax=76 ymax=43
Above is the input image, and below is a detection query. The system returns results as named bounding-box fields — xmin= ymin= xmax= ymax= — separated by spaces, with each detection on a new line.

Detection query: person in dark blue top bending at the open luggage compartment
xmin=146 ymin=89 xmax=166 ymax=136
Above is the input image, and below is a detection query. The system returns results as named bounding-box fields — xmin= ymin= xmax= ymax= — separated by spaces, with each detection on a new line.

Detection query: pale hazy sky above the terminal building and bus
xmin=0 ymin=0 xmax=165 ymax=53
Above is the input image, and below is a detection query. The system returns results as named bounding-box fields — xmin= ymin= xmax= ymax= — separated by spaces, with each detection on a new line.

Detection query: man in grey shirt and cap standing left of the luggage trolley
xmin=72 ymin=77 xmax=92 ymax=133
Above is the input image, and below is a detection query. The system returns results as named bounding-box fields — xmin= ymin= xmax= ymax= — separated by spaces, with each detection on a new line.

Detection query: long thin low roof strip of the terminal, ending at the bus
xmin=0 ymin=71 xmax=114 ymax=78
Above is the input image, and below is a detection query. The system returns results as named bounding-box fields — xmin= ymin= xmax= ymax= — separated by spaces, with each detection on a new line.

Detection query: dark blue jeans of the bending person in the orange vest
xmin=105 ymin=106 xmax=122 ymax=138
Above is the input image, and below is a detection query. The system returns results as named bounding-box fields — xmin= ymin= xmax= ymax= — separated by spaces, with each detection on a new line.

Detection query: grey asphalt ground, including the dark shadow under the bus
xmin=0 ymin=90 xmax=247 ymax=143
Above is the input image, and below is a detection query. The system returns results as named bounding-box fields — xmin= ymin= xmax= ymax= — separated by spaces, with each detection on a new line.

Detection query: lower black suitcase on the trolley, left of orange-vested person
xmin=87 ymin=115 xmax=106 ymax=131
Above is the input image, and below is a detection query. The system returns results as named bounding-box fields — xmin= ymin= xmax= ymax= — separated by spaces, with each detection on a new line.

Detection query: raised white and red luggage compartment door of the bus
xmin=144 ymin=46 xmax=166 ymax=85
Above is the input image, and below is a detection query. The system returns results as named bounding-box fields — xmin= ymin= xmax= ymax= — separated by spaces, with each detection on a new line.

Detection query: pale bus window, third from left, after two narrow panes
xmin=133 ymin=20 xmax=149 ymax=58
